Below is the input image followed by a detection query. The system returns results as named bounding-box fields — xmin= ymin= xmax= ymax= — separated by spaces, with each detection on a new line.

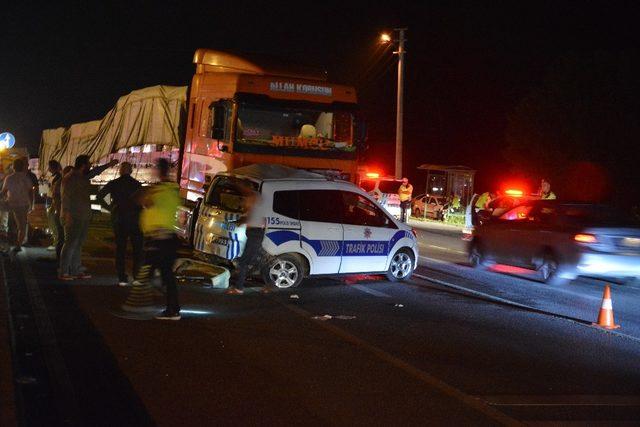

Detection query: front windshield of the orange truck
xmin=236 ymin=104 xmax=355 ymax=152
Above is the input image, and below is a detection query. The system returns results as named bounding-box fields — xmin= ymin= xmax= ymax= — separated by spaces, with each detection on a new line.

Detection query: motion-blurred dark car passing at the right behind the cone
xmin=469 ymin=200 xmax=640 ymax=283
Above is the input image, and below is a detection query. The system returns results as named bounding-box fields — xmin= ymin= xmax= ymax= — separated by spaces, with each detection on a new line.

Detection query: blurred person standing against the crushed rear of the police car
xmin=226 ymin=185 xmax=270 ymax=295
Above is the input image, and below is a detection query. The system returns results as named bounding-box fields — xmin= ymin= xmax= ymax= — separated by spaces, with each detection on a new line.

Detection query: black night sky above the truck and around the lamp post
xmin=0 ymin=1 xmax=640 ymax=191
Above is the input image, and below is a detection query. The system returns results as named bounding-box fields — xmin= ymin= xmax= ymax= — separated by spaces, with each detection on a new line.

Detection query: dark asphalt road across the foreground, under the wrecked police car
xmin=2 ymin=222 xmax=640 ymax=426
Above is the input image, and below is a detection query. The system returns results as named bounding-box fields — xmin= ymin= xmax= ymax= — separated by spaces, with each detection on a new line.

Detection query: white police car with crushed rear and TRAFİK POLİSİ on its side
xmin=193 ymin=164 xmax=418 ymax=288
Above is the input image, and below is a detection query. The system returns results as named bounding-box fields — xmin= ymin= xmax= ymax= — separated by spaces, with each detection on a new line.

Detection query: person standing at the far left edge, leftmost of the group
xmin=0 ymin=159 xmax=34 ymax=252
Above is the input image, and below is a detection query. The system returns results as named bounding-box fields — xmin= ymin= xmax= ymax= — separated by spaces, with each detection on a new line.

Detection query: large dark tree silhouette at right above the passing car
xmin=504 ymin=52 xmax=640 ymax=205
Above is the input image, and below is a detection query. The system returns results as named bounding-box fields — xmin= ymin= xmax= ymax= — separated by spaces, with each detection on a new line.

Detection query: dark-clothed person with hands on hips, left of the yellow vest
xmin=96 ymin=162 xmax=143 ymax=286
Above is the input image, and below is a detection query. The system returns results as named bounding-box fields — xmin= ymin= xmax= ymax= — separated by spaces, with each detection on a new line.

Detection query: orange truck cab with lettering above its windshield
xmin=178 ymin=49 xmax=364 ymax=239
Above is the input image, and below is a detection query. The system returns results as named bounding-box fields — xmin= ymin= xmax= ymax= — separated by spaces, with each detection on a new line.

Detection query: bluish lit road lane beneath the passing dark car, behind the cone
xmin=413 ymin=223 xmax=640 ymax=339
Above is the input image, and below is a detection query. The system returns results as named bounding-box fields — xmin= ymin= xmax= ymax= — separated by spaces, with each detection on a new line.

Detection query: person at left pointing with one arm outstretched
xmin=58 ymin=154 xmax=118 ymax=281
